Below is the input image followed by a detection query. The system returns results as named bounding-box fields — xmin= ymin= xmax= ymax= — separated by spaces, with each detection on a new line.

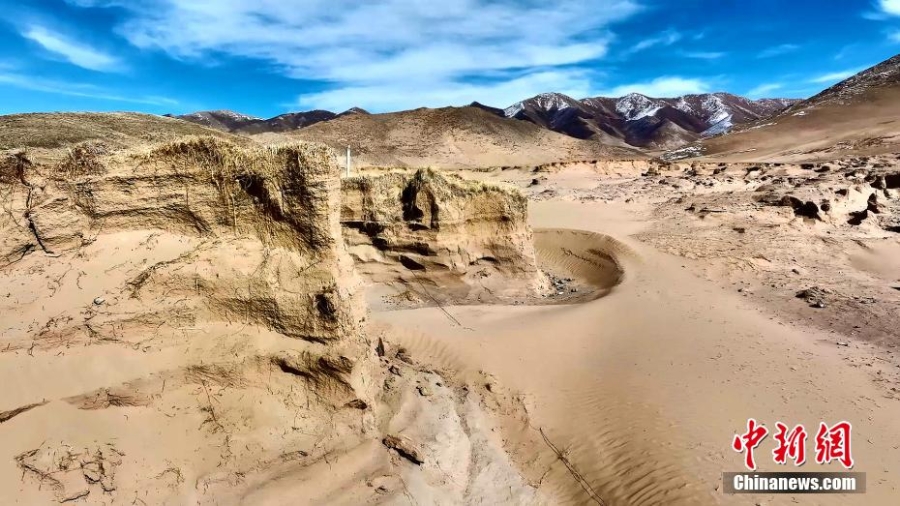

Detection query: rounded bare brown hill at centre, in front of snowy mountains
xmin=254 ymin=106 xmax=643 ymax=167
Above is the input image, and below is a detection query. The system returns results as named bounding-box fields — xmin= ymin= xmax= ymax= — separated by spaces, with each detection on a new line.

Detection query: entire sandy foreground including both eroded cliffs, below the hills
xmin=0 ymin=115 xmax=900 ymax=505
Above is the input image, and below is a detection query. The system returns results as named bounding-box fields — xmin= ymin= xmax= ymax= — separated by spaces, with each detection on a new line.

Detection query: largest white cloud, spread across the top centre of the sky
xmin=69 ymin=0 xmax=641 ymax=110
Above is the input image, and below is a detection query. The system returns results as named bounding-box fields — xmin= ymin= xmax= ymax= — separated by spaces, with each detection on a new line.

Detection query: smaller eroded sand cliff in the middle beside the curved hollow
xmin=341 ymin=169 xmax=546 ymax=302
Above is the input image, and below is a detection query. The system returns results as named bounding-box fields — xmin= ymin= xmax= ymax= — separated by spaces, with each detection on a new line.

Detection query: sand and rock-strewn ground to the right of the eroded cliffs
xmin=366 ymin=156 xmax=900 ymax=504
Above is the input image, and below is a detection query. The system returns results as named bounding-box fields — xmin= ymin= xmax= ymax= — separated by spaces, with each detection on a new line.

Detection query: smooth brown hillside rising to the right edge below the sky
xmin=675 ymin=55 xmax=900 ymax=161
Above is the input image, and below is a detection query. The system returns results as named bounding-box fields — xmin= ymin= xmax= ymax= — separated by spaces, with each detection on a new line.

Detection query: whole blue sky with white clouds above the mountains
xmin=0 ymin=0 xmax=900 ymax=117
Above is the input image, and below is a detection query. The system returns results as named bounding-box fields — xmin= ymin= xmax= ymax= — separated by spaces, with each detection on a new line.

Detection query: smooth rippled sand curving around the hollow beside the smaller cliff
xmin=373 ymin=202 xmax=900 ymax=504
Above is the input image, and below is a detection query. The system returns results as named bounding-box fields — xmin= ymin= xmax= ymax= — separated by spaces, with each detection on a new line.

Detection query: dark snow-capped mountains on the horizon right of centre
xmin=504 ymin=93 xmax=796 ymax=148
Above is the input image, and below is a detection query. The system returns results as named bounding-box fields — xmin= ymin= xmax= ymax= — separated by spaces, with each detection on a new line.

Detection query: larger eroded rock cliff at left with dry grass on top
xmin=0 ymin=138 xmax=362 ymax=341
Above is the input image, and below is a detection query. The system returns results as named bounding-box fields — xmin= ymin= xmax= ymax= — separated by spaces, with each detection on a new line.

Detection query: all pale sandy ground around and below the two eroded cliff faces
xmin=0 ymin=147 xmax=900 ymax=505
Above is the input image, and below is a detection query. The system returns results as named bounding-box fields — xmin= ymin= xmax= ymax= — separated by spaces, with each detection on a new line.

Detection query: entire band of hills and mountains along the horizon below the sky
xmin=8 ymin=55 xmax=900 ymax=167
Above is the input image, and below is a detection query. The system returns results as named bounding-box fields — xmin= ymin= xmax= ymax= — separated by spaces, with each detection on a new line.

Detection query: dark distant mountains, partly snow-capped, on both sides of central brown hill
xmin=176 ymin=93 xmax=797 ymax=150
